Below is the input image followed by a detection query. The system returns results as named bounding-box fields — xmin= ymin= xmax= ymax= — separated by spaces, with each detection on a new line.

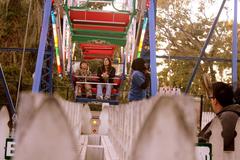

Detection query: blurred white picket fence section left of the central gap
xmin=12 ymin=94 xmax=91 ymax=160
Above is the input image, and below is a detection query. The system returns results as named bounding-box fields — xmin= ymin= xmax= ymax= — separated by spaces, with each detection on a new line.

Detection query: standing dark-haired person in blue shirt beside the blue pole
xmin=128 ymin=58 xmax=150 ymax=101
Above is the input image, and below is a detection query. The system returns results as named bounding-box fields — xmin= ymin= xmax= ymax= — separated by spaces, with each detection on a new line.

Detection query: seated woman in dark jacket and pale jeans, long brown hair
xmin=96 ymin=58 xmax=116 ymax=100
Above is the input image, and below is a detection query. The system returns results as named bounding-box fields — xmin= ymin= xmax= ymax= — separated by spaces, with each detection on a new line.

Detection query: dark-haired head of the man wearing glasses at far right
xmin=210 ymin=82 xmax=233 ymax=113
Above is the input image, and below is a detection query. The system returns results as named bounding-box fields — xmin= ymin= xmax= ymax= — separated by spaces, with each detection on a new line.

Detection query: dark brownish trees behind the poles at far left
xmin=0 ymin=0 xmax=72 ymax=104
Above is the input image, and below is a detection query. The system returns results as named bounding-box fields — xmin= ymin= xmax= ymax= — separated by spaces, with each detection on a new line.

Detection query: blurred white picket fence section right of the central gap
xmin=108 ymin=96 xmax=196 ymax=160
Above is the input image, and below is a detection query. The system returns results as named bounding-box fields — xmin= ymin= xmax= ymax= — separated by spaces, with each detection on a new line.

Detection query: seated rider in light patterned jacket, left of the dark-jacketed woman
xmin=74 ymin=61 xmax=92 ymax=97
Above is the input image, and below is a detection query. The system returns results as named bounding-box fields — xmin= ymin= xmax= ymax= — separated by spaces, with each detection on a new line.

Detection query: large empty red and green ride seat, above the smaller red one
xmin=67 ymin=8 xmax=132 ymax=46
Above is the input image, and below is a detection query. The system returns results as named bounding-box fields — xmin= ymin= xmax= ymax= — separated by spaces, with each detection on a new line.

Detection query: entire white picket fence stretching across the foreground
xmin=0 ymin=94 xmax=240 ymax=160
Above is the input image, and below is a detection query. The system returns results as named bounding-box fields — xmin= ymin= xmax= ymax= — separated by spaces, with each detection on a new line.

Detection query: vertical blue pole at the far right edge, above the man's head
xmin=232 ymin=0 xmax=238 ymax=91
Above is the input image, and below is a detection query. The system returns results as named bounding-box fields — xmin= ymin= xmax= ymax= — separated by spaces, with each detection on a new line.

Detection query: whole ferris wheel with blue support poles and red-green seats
xmin=0 ymin=0 xmax=238 ymax=159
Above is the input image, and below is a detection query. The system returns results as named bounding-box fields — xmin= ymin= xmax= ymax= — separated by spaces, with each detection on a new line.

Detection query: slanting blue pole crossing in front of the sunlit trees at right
xmin=185 ymin=0 xmax=226 ymax=94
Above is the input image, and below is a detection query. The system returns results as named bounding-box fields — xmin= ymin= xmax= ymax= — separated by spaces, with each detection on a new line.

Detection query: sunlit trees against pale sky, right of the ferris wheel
xmin=157 ymin=0 xmax=238 ymax=95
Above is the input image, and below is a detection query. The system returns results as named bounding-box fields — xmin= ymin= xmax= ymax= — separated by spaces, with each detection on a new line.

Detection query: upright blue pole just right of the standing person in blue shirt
xmin=148 ymin=0 xmax=158 ymax=96
